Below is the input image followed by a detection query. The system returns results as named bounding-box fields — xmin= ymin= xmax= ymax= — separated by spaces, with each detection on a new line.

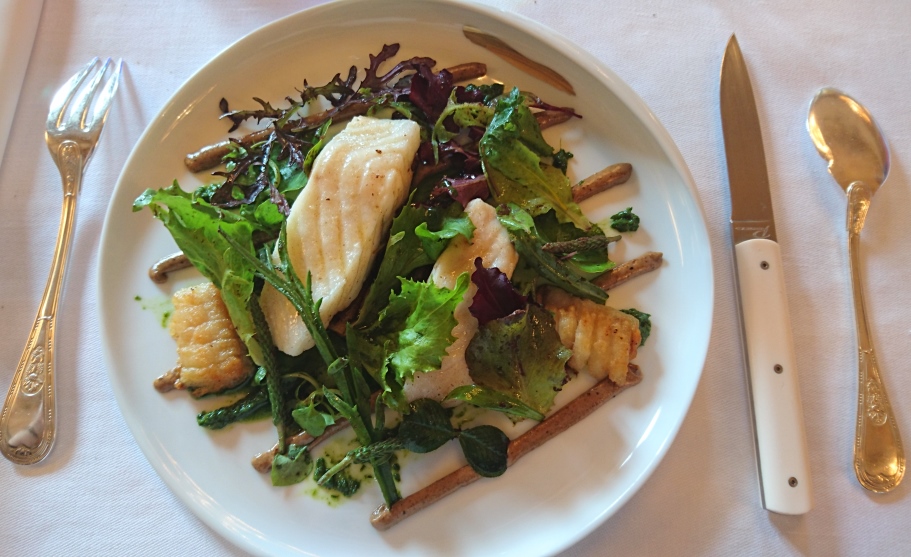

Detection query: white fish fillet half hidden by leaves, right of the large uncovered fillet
xmin=405 ymin=199 xmax=519 ymax=401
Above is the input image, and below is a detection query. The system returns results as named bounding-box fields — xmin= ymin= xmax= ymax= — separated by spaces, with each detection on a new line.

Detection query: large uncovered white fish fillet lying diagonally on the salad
xmin=260 ymin=116 xmax=420 ymax=356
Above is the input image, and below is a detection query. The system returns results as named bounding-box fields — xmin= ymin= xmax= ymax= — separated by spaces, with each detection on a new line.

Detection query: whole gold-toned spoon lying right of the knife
xmin=807 ymin=88 xmax=905 ymax=493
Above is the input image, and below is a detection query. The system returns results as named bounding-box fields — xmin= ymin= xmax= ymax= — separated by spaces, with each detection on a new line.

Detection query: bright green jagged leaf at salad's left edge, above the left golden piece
xmin=133 ymin=180 xmax=263 ymax=364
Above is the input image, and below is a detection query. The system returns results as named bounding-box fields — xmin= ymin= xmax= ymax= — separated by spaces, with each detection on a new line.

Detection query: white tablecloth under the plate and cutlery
xmin=0 ymin=0 xmax=911 ymax=557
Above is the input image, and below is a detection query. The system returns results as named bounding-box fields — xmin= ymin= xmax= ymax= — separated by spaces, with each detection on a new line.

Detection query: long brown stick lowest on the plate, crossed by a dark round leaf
xmin=370 ymin=364 xmax=642 ymax=530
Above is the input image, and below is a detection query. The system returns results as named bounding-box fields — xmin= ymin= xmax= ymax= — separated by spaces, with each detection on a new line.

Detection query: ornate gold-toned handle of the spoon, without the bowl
xmin=847 ymin=182 xmax=905 ymax=493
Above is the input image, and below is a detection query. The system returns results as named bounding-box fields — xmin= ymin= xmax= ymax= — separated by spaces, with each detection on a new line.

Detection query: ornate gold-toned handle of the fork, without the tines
xmin=0 ymin=141 xmax=85 ymax=464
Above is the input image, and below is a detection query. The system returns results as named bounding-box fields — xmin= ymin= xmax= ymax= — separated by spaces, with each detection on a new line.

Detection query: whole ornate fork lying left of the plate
xmin=0 ymin=58 xmax=122 ymax=464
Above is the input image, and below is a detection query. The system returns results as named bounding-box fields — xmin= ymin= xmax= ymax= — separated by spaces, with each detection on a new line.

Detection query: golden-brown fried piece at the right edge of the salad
xmin=544 ymin=288 xmax=642 ymax=385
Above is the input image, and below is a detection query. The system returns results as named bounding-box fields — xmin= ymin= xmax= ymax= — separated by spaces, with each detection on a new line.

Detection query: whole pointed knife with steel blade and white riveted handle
xmin=720 ymin=35 xmax=812 ymax=514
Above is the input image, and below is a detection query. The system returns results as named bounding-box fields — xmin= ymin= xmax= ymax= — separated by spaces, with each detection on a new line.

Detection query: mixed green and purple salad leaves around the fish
xmin=133 ymin=45 xmax=648 ymax=506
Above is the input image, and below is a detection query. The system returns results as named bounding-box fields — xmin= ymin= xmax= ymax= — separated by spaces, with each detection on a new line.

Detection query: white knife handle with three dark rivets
xmin=734 ymin=239 xmax=812 ymax=514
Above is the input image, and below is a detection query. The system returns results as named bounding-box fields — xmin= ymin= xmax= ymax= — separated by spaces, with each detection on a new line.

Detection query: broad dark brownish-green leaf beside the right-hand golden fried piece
xmin=465 ymin=304 xmax=572 ymax=414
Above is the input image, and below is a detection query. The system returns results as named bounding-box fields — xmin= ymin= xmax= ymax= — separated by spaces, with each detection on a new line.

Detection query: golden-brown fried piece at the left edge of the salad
xmin=168 ymin=282 xmax=253 ymax=397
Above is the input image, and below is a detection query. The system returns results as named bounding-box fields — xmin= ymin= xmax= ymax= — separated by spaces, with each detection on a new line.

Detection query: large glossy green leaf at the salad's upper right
xmin=479 ymin=89 xmax=591 ymax=229
